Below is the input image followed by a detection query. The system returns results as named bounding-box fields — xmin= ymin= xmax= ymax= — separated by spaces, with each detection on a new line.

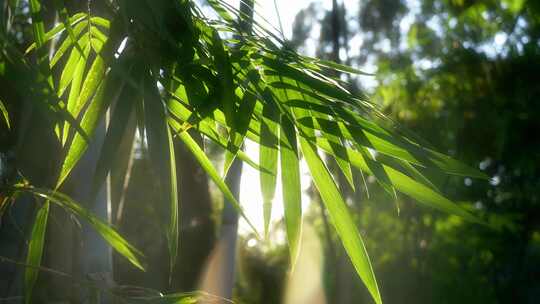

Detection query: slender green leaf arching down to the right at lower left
xmin=16 ymin=187 xmax=144 ymax=271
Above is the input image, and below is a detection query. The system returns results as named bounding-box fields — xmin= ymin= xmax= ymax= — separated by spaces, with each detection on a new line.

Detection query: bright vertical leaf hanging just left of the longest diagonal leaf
xmin=279 ymin=116 xmax=302 ymax=270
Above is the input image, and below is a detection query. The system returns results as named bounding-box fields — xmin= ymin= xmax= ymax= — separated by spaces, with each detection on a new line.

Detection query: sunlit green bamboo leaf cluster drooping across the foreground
xmin=0 ymin=0 xmax=486 ymax=303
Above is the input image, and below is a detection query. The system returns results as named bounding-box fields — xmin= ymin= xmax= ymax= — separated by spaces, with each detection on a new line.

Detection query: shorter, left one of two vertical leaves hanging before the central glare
xmin=259 ymin=104 xmax=279 ymax=236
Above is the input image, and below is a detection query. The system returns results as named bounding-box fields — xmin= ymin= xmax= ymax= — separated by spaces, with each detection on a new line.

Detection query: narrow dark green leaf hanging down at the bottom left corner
xmin=24 ymin=202 xmax=49 ymax=304
